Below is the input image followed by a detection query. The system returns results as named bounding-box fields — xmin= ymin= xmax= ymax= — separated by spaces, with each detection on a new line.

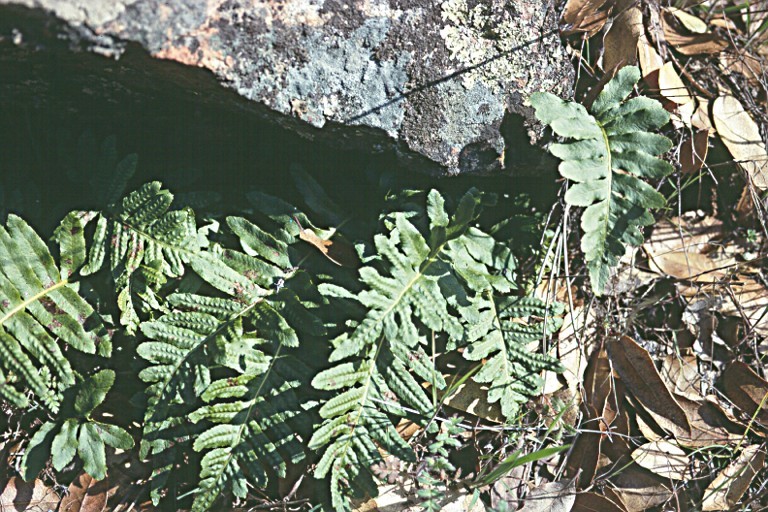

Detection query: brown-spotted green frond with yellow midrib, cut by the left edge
xmin=0 ymin=215 xmax=112 ymax=413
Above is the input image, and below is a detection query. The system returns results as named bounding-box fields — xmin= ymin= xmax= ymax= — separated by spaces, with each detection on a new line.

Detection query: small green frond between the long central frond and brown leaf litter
xmin=464 ymin=291 xmax=563 ymax=420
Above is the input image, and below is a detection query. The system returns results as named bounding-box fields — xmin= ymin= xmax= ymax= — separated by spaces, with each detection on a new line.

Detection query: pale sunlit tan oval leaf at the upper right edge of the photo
xmin=712 ymin=96 xmax=768 ymax=190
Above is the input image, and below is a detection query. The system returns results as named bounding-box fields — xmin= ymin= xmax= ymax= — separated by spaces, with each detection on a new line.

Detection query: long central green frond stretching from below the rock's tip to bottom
xmin=309 ymin=189 xmax=511 ymax=510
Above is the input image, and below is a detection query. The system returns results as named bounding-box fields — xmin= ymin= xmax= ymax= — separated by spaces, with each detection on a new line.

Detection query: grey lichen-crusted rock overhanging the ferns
xmin=0 ymin=0 xmax=573 ymax=175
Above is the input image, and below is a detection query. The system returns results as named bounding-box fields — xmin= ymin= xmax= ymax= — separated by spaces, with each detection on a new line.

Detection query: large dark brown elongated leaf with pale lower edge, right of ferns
xmin=607 ymin=336 xmax=691 ymax=435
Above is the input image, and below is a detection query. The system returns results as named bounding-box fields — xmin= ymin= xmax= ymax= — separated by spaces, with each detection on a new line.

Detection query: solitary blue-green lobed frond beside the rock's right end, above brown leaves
xmin=530 ymin=66 xmax=673 ymax=294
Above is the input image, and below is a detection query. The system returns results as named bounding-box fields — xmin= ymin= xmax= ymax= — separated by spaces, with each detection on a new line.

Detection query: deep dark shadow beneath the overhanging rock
xmin=0 ymin=7 xmax=556 ymax=233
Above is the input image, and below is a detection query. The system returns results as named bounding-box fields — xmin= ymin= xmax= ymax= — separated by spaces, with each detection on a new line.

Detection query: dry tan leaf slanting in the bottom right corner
xmin=702 ymin=444 xmax=765 ymax=512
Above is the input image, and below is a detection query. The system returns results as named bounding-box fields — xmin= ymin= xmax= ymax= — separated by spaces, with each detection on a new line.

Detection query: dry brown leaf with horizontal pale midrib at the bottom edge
xmin=605 ymin=464 xmax=673 ymax=512
